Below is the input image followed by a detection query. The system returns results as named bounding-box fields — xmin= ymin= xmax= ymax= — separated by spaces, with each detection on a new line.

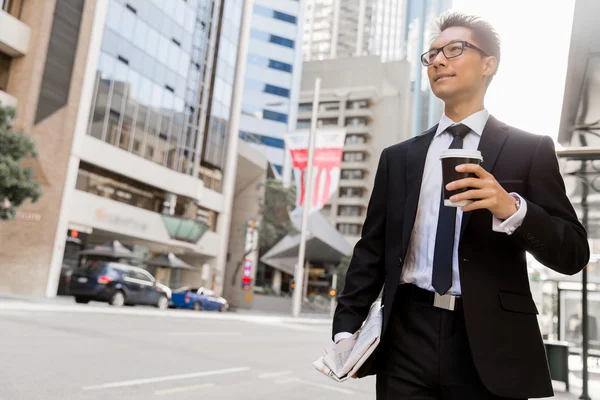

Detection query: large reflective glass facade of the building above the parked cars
xmin=88 ymin=0 xmax=212 ymax=174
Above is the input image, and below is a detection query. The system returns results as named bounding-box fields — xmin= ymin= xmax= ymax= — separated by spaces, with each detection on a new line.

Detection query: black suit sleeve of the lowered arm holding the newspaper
xmin=333 ymin=150 xmax=388 ymax=336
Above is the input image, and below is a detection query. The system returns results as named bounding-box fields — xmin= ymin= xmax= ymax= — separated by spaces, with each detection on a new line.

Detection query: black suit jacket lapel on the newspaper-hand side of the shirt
xmin=402 ymin=125 xmax=437 ymax=257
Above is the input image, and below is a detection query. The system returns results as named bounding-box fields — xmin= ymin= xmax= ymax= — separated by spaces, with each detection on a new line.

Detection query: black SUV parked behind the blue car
xmin=69 ymin=260 xmax=171 ymax=309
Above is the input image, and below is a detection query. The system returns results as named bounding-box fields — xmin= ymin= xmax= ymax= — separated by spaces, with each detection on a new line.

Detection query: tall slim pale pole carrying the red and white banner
xmin=292 ymin=78 xmax=321 ymax=318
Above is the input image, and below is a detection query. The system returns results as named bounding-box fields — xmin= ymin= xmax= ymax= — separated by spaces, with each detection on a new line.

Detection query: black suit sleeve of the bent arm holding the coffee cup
xmin=512 ymin=136 xmax=590 ymax=275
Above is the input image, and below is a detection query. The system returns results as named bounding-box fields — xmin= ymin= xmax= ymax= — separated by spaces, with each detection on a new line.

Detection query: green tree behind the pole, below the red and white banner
xmin=258 ymin=178 xmax=298 ymax=254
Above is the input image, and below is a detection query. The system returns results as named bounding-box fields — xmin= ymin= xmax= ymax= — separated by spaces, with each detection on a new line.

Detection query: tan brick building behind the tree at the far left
xmin=0 ymin=0 xmax=105 ymax=295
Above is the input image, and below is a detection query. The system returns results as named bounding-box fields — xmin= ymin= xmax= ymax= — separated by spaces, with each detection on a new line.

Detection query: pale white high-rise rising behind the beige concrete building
xmin=303 ymin=0 xmax=405 ymax=61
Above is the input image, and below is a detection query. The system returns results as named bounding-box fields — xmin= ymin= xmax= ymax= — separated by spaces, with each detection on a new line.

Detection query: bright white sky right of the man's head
xmin=454 ymin=0 xmax=575 ymax=139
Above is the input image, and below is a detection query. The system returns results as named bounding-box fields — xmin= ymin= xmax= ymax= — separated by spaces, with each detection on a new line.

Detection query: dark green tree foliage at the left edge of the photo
xmin=0 ymin=106 xmax=42 ymax=220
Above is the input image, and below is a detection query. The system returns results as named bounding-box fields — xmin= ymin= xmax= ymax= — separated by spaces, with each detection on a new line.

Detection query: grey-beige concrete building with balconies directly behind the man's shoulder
xmin=298 ymin=56 xmax=411 ymax=245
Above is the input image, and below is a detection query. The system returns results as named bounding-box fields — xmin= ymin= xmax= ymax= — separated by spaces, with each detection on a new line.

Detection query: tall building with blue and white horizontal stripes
xmin=240 ymin=0 xmax=303 ymax=174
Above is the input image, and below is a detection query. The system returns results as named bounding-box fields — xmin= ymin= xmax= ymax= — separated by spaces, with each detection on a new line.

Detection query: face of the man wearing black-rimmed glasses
xmin=427 ymin=26 xmax=495 ymax=102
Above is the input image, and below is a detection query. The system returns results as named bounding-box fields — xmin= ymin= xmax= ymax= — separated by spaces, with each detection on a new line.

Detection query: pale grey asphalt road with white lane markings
xmin=0 ymin=302 xmax=375 ymax=400
